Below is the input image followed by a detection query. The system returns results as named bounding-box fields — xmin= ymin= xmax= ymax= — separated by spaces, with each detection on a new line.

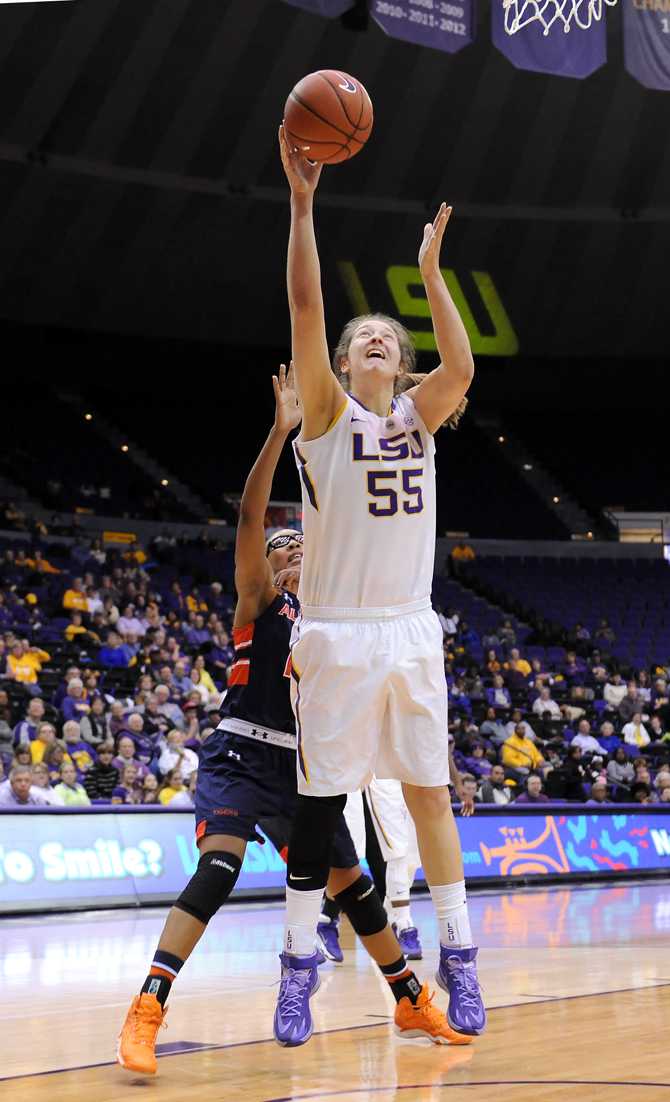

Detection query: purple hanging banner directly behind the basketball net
xmin=490 ymin=0 xmax=607 ymax=79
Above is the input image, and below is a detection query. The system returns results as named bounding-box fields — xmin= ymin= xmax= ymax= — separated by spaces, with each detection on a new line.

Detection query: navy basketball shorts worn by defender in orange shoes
xmin=195 ymin=731 xmax=358 ymax=868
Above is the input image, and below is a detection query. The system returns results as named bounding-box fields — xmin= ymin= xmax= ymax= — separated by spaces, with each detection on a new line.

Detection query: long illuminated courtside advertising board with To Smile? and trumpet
xmin=0 ymin=804 xmax=670 ymax=915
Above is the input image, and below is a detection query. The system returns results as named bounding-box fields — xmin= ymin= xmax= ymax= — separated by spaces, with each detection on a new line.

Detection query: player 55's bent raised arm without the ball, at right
xmin=413 ymin=203 xmax=475 ymax=432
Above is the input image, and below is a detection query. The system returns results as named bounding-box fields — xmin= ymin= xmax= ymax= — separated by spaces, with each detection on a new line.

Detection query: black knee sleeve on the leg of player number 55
xmin=287 ymin=796 xmax=347 ymax=892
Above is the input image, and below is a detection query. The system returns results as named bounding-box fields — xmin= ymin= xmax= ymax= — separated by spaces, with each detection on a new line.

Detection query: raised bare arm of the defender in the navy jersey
xmin=235 ymin=364 xmax=301 ymax=623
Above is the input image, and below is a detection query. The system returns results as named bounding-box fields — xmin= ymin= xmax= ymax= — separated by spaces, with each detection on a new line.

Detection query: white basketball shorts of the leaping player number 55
xmin=291 ymin=601 xmax=449 ymax=796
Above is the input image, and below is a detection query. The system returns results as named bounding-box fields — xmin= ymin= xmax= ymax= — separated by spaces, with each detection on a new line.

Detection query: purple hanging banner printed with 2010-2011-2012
xmin=370 ymin=0 xmax=475 ymax=54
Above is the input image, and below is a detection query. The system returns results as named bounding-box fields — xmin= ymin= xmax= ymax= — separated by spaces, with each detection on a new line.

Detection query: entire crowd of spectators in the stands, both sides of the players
xmin=0 ymin=541 xmax=670 ymax=808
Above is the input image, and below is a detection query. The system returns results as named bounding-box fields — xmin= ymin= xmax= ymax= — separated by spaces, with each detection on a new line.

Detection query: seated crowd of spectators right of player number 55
xmin=440 ymin=609 xmax=670 ymax=806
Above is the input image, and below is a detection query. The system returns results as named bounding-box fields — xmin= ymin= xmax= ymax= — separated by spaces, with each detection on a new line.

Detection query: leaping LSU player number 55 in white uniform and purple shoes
xmin=274 ymin=128 xmax=486 ymax=1044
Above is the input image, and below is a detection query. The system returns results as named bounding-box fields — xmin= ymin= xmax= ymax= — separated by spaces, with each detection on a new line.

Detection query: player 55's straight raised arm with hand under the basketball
xmin=279 ymin=127 xmax=345 ymax=440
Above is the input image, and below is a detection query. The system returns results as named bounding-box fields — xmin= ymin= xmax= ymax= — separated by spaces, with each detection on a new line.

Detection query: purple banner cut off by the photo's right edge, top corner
xmin=622 ymin=0 xmax=670 ymax=91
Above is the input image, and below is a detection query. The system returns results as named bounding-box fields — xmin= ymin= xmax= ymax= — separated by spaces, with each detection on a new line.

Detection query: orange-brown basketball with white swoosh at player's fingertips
xmin=284 ymin=69 xmax=372 ymax=164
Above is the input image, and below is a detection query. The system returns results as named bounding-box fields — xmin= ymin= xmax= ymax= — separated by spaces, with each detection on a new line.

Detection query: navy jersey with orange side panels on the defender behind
xmin=219 ymin=592 xmax=300 ymax=734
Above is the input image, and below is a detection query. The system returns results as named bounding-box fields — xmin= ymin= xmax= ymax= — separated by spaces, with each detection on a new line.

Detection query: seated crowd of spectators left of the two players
xmin=0 ymin=543 xmax=235 ymax=808
